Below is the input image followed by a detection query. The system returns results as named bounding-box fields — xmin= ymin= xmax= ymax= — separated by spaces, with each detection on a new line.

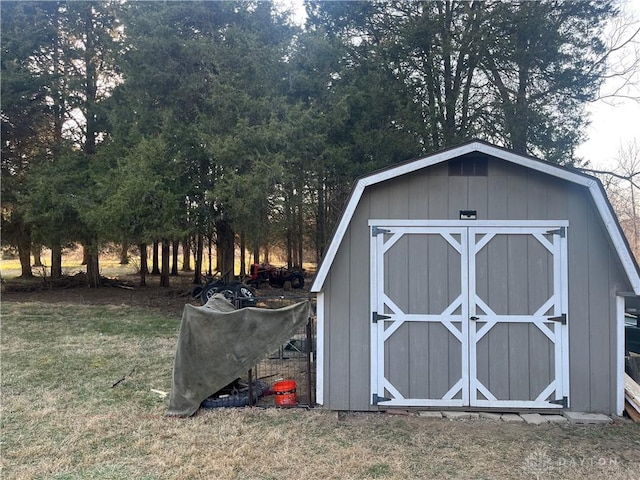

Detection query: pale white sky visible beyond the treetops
xmin=276 ymin=0 xmax=640 ymax=170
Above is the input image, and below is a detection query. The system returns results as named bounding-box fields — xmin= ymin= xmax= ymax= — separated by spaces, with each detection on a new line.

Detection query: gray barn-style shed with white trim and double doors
xmin=311 ymin=141 xmax=640 ymax=414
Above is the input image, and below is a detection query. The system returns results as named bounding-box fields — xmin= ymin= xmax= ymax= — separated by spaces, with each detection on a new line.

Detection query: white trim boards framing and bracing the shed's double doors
xmin=368 ymin=219 xmax=569 ymax=408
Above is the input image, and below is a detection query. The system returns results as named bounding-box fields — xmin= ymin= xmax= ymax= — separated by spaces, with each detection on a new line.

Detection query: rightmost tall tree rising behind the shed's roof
xmin=482 ymin=0 xmax=616 ymax=163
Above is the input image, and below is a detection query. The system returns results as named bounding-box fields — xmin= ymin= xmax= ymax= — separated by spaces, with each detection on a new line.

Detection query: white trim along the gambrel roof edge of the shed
xmin=311 ymin=142 xmax=640 ymax=295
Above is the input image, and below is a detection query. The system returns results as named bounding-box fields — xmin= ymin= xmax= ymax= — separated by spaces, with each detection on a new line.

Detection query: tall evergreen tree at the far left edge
xmin=0 ymin=2 xmax=56 ymax=277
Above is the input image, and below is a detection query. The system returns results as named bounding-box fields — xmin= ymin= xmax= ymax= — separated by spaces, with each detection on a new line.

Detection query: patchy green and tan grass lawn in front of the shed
xmin=0 ymin=302 xmax=640 ymax=480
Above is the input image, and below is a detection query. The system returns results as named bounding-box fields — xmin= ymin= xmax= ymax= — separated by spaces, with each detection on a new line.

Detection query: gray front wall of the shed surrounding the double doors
xmin=323 ymin=158 xmax=631 ymax=413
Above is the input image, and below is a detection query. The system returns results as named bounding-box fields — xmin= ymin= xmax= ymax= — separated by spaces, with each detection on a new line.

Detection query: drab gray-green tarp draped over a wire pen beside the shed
xmin=167 ymin=294 xmax=311 ymax=416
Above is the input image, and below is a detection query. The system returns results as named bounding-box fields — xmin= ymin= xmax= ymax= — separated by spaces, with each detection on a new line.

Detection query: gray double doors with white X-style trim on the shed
xmin=369 ymin=220 xmax=569 ymax=408
